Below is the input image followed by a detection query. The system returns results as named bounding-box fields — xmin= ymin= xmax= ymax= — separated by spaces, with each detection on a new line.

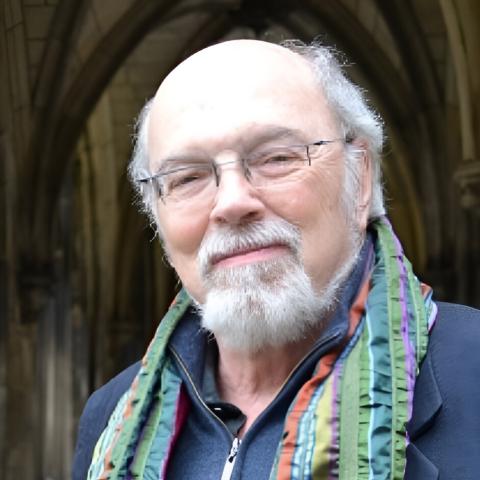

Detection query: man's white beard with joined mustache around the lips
xmin=198 ymin=220 xmax=356 ymax=352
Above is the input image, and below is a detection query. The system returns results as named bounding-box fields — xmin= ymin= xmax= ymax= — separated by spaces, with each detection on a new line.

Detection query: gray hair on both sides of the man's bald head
xmin=128 ymin=40 xmax=385 ymax=230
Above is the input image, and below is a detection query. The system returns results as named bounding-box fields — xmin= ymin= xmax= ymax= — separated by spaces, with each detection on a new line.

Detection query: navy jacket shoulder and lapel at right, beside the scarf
xmin=405 ymin=302 xmax=480 ymax=480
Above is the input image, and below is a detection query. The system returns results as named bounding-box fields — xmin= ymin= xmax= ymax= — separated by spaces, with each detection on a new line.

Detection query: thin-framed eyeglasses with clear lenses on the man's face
xmin=137 ymin=138 xmax=346 ymax=205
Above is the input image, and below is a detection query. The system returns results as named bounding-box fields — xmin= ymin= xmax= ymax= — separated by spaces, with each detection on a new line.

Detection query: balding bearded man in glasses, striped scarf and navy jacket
xmin=73 ymin=40 xmax=480 ymax=480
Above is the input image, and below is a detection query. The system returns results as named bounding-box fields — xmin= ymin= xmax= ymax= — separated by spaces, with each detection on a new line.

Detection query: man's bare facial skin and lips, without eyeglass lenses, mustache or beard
xmin=149 ymin=42 xmax=365 ymax=303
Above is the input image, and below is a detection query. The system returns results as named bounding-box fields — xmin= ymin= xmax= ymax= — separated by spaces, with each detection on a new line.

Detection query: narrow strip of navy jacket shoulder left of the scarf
xmin=72 ymin=362 xmax=140 ymax=480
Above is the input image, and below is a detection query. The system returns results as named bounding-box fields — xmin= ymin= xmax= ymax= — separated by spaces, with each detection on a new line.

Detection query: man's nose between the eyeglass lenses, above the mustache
xmin=210 ymin=161 xmax=265 ymax=225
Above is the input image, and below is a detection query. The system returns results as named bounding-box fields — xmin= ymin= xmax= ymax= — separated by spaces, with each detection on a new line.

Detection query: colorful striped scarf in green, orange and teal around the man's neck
xmin=88 ymin=219 xmax=436 ymax=480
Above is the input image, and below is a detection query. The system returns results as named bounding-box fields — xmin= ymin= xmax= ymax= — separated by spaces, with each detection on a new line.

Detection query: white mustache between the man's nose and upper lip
xmin=197 ymin=219 xmax=301 ymax=276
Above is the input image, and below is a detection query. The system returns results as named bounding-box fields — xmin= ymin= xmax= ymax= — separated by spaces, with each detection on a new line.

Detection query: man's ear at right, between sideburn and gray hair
xmin=353 ymin=138 xmax=373 ymax=231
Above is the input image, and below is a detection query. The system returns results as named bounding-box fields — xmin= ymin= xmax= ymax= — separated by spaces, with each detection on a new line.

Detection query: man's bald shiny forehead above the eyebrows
xmin=149 ymin=42 xmax=337 ymax=156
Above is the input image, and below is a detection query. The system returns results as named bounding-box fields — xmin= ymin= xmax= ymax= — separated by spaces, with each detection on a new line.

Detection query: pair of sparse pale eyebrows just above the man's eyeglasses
xmin=152 ymin=124 xmax=304 ymax=175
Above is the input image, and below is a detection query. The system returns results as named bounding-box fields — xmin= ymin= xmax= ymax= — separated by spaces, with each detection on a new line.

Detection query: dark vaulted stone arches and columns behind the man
xmin=0 ymin=0 xmax=480 ymax=480
